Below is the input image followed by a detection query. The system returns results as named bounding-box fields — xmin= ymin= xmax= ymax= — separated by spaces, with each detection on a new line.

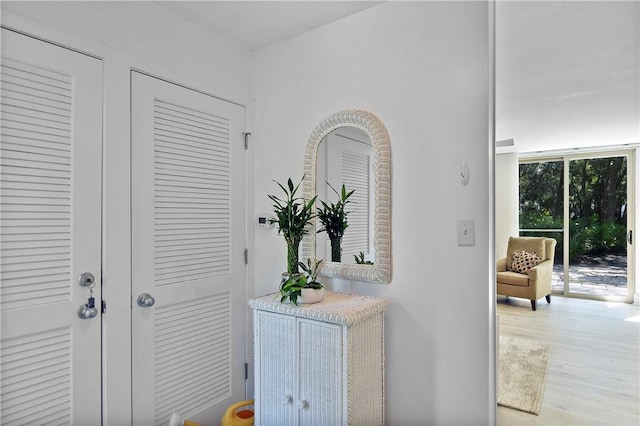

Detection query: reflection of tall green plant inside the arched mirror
xmin=317 ymin=182 xmax=355 ymax=262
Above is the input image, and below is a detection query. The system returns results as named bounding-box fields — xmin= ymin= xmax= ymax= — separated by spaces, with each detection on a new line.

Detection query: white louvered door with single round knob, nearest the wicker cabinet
xmin=131 ymin=72 xmax=247 ymax=425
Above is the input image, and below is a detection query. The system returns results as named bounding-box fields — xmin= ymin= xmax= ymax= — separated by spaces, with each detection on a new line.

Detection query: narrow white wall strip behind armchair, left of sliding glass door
xmin=495 ymin=152 xmax=520 ymax=259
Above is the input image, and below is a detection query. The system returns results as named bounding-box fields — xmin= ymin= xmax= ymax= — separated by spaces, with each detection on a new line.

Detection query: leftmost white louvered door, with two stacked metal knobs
xmin=0 ymin=29 xmax=102 ymax=425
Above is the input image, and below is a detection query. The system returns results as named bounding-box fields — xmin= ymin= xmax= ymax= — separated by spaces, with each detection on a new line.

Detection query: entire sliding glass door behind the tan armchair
xmin=520 ymin=151 xmax=634 ymax=302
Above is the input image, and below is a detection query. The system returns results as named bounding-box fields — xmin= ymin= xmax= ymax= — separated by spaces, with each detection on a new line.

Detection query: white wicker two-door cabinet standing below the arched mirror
xmin=249 ymin=292 xmax=387 ymax=426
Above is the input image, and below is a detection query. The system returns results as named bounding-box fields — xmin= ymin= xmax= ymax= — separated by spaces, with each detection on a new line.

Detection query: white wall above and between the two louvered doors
xmin=2 ymin=2 xmax=251 ymax=425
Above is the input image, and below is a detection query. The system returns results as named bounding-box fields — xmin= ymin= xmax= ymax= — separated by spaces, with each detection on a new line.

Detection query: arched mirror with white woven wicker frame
xmin=301 ymin=110 xmax=391 ymax=283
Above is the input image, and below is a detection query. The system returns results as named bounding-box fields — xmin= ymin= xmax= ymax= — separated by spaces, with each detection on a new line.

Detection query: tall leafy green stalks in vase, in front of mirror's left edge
xmin=269 ymin=176 xmax=316 ymax=275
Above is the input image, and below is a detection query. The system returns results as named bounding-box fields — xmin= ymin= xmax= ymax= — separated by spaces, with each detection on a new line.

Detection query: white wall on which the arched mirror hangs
xmin=252 ymin=1 xmax=495 ymax=425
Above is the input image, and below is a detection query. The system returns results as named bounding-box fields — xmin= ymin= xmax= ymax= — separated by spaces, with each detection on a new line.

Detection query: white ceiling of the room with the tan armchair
xmin=496 ymin=1 xmax=640 ymax=152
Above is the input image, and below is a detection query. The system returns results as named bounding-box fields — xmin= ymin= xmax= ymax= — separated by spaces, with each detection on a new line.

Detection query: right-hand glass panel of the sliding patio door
xmin=565 ymin=155 xmax=630 ymax=301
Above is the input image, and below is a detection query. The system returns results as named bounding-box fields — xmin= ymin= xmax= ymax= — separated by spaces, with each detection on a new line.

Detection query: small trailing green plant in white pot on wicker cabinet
xmin=280 ymin=259 xmax=325 ymax=305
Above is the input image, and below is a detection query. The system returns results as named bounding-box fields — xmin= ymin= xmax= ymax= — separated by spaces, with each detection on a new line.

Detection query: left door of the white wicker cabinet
xmin=255 ymin=311 xmax=298 ymax=426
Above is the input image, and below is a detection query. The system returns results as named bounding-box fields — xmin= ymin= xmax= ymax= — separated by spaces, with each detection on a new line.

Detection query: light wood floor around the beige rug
xmin=497 ymin=295 xmax=640 ymax=426
